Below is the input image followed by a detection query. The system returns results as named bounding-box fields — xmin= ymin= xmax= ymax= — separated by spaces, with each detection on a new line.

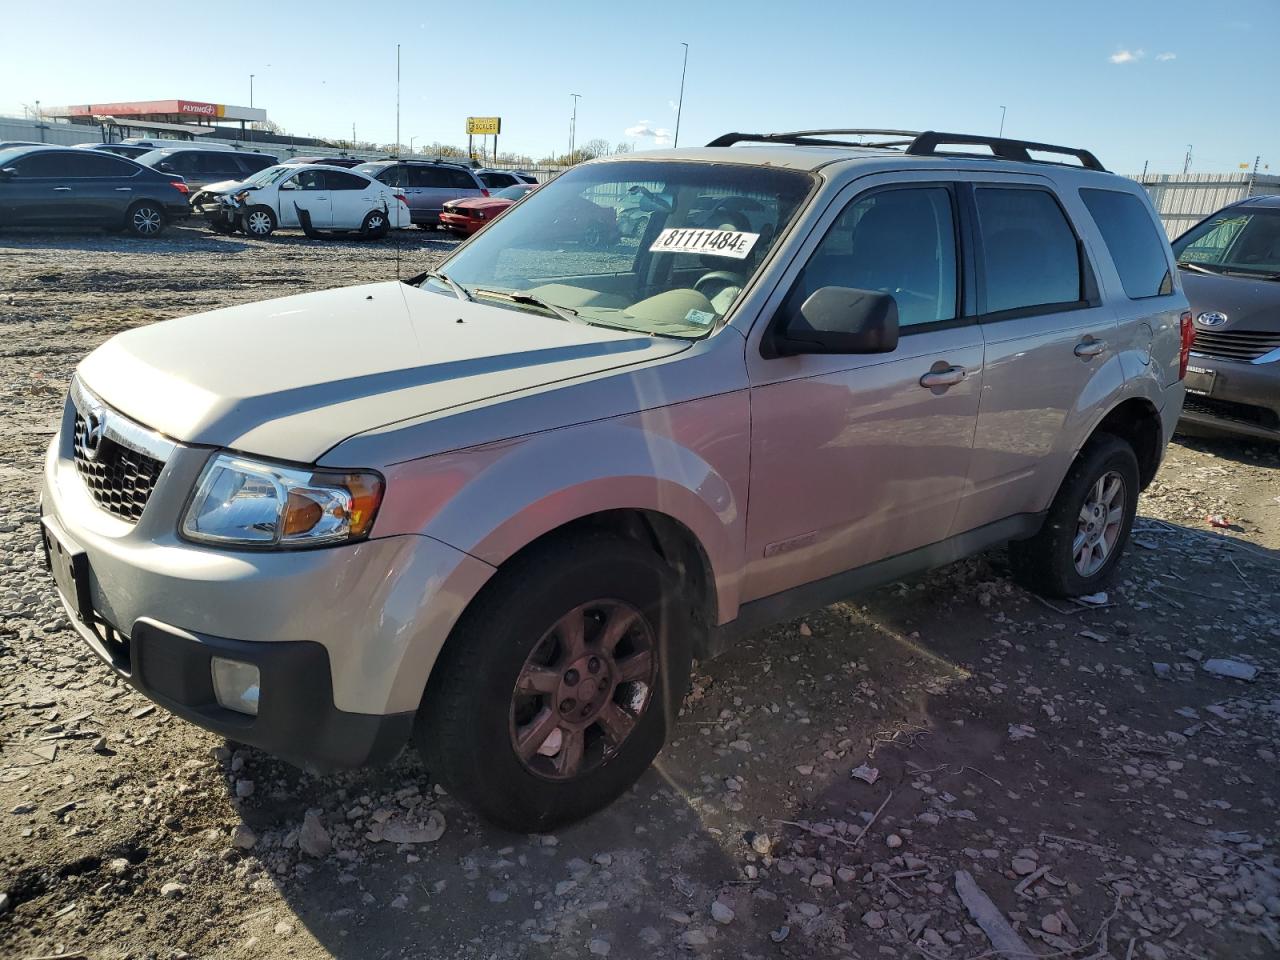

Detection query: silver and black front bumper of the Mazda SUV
xmin=41 ymin=386 xmax=493 ymax=767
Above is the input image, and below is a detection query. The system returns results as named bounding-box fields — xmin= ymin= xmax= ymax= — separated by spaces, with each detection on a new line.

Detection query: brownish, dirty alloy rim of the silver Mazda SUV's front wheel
xmin=508 ymin=599 xmax=658 ymax=781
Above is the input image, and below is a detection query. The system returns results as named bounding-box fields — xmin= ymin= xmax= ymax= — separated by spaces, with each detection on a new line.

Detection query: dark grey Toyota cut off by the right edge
xmin=1172 ymin=197 xmax=1280 ymax=443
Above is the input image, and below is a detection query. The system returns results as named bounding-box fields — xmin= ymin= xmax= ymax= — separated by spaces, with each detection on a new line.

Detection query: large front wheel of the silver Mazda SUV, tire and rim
xmin=415 ymin=534 xmax=694 ymax=832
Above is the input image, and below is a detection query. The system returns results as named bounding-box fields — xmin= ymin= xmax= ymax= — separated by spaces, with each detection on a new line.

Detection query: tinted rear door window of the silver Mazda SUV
xmin=974 ymin=187 xmax=1082 ymax=314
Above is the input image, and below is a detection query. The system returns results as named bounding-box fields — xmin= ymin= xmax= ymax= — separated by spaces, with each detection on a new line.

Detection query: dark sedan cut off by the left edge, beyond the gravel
xmin=0 ymin=147 xmax=191 ymax=237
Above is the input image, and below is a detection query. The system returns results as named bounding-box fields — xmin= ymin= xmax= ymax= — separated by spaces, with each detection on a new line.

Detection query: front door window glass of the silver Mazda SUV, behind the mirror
xmin=790 ymin=187 xmax=957 ymax=328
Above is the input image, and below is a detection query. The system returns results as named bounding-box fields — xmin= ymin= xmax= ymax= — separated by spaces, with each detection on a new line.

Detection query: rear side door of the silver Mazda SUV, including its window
xmin=956 ymin=175 xmax=1124 ymax=532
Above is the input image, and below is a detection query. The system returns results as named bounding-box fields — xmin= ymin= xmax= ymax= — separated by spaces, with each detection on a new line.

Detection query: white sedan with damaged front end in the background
xmin=191 ymin=164 xmax=411 ymax=238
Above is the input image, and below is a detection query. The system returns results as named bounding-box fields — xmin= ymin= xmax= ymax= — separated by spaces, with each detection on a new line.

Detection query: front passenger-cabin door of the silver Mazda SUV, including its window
xmin=742 ymin=175 xmax=983 ymax=602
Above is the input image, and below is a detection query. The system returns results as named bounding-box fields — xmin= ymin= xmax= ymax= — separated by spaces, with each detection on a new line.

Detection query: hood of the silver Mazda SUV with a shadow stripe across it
xmin=78 ymin=282 xmax=689 ymax=466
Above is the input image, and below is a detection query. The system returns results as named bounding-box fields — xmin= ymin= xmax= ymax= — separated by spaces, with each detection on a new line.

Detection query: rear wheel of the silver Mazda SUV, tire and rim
xmin=1009 ymin=434 xmax=1139 ymax=596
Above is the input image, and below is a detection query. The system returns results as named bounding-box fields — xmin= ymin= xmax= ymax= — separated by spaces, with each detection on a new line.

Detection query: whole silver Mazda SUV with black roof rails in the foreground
xmin=42 ymin=131 xmax=1192 ymax=831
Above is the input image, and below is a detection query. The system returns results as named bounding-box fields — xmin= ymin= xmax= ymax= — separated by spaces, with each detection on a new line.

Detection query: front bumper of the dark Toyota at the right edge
xmin=1181 ymin=352 xmax=1280 ymax=442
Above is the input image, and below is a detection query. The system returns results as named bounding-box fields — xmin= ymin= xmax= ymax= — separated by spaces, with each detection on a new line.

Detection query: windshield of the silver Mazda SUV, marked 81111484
xmin=424 ymin=160 xmax=813 ymax=338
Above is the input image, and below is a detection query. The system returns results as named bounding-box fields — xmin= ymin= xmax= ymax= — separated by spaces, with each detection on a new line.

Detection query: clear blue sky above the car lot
xmin=0 ymin=0 xmax=1280 ymax=174
